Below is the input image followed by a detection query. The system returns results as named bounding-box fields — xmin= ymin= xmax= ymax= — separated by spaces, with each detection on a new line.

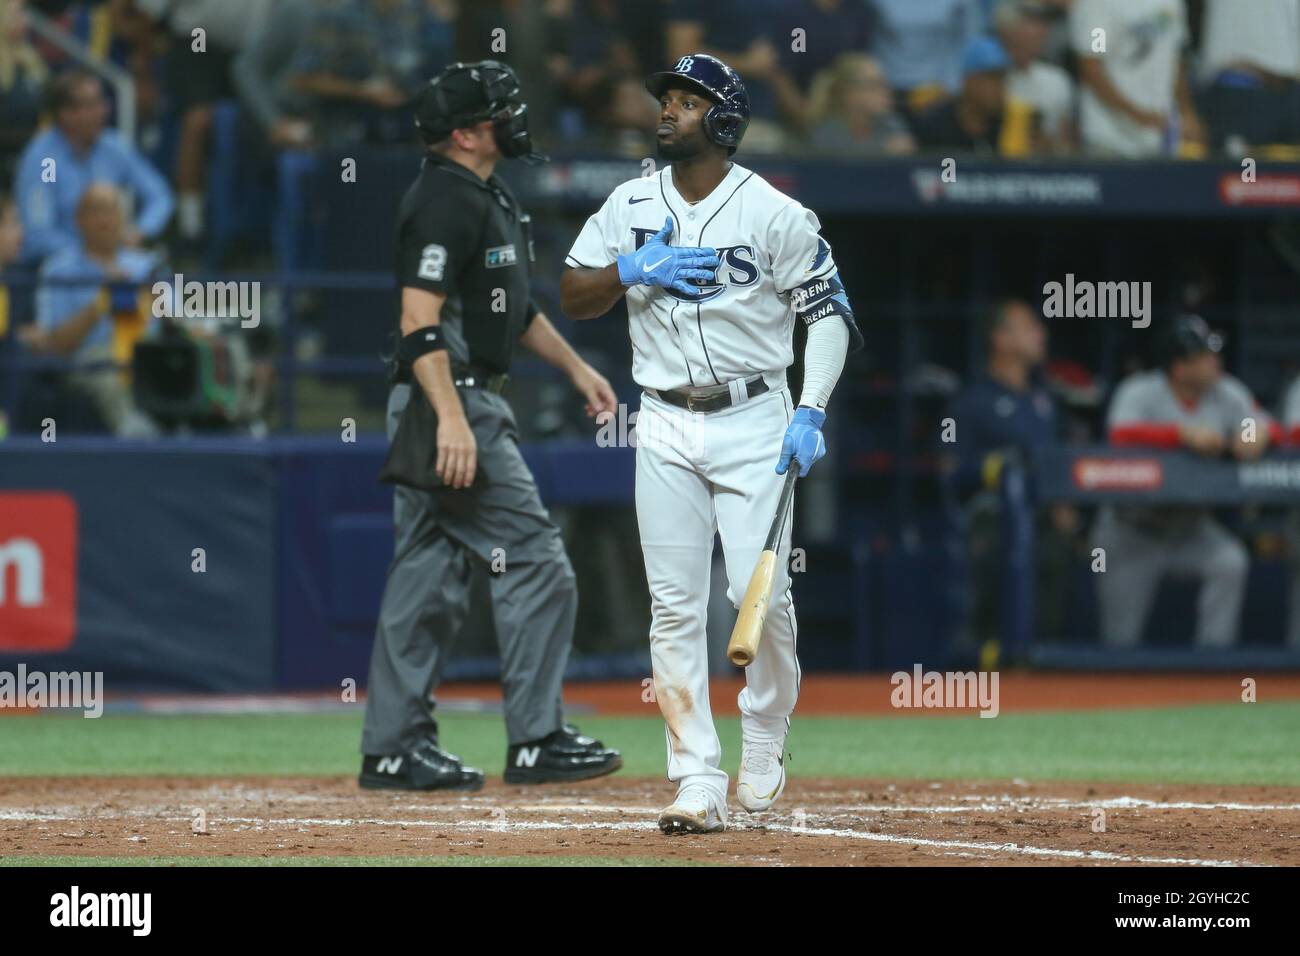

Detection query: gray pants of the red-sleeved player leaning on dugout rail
xmin=1092 ymin=510 xmax=1251 ymax=648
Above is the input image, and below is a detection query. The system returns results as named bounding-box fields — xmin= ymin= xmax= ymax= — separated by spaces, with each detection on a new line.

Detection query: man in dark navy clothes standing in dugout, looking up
xmin=945 ymin=299 xmax=1079 ymax=658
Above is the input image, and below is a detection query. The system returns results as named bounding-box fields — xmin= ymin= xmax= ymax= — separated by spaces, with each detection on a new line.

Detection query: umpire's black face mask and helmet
xmin=415 ymin=60 xmax=545 ymax=163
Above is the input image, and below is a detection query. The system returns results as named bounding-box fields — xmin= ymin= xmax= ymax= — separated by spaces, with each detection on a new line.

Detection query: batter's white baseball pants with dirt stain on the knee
xmin=636 ymin=382 xmax=800 ymax=805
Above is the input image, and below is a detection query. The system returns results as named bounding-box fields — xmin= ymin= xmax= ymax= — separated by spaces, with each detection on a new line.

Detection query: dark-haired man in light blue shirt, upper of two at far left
xmin=14 ymin=69 xmax=174 ymax=261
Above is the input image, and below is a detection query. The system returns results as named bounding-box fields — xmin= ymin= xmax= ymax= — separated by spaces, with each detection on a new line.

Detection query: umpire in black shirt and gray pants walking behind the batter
xmin=360 ymin=60 xmax=623 ymax=790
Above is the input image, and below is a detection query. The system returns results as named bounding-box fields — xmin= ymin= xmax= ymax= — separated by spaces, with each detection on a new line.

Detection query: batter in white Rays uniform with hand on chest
xmin=560 ymin=53 xmax=862 ymax=832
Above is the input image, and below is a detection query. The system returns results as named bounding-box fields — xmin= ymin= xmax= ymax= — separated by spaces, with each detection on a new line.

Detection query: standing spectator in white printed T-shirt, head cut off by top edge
xmin=1070 ymin=0 xmax=1204 ymax=159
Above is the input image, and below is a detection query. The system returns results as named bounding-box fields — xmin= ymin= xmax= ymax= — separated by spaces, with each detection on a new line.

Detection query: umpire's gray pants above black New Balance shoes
xmin=361 ymin=385 xmax=577 ymax=756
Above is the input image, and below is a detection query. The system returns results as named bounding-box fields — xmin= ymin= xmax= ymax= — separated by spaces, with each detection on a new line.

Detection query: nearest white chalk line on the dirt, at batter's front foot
xmin=0 ymin=808 xmax=1260 ymax=866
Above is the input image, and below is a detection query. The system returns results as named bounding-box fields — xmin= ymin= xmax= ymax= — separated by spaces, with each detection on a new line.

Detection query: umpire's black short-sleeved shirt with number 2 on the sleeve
xmin=397 ymin=153 xmax=540 ymax=373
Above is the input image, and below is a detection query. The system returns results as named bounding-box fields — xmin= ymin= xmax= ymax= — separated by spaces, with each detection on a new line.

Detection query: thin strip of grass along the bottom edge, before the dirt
xmin=0 ymin=855 xmax=712 ymax=868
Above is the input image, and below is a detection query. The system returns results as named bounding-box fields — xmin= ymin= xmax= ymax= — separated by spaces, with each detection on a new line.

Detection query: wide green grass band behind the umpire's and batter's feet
xmin=0 ymin=701 xmax=1300 ymax=786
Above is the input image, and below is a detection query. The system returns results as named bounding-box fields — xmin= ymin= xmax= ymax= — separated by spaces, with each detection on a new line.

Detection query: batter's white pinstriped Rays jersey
xmin=566 ymin=163 xmax=836 ymax=390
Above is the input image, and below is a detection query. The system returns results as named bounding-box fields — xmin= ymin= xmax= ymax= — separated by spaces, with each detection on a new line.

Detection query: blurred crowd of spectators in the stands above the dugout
xmin=0 ymin=0 xmax=1300 ymax=251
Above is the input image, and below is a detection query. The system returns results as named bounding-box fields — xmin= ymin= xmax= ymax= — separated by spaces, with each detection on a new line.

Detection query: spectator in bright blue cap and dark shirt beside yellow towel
xmin=913 ymin=36 xmax=1037 ymax=157
